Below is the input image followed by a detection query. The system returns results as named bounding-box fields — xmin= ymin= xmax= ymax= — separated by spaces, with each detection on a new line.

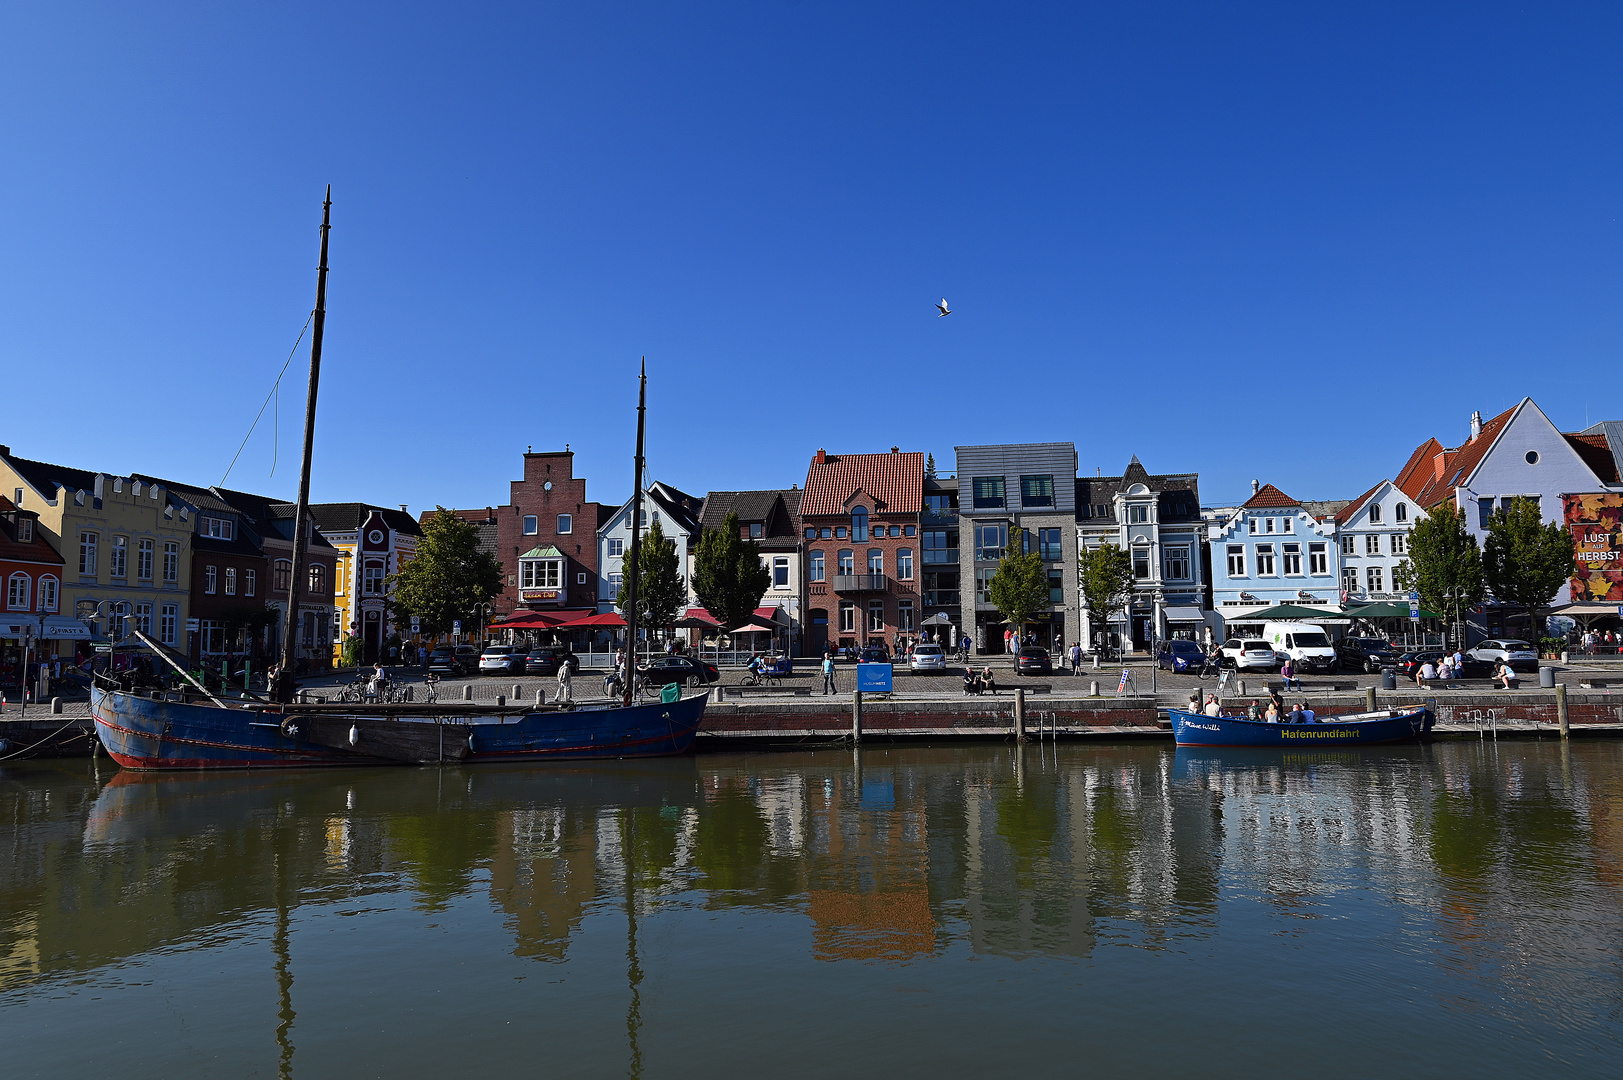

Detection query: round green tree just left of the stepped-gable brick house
xmin=390 ymin=507 xmax=502 ymax=637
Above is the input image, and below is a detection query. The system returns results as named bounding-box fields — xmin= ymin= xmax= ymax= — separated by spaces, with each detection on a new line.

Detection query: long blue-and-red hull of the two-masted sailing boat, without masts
xmin=91 ymin=685 xmax=706 ymax=770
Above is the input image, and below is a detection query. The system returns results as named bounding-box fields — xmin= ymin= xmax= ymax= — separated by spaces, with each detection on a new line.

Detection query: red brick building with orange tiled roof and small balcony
xmin=800 ymin=447 xmax=923 ymax=654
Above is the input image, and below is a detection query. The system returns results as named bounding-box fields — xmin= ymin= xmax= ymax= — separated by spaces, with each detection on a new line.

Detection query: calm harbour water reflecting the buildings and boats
xmin=0 ymin=741 xmax=1623 ymax=1080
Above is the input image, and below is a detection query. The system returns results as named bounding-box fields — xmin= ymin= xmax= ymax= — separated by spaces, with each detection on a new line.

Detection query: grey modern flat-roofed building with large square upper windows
xmin=956 ymin=442 xmax=1081 ymax=654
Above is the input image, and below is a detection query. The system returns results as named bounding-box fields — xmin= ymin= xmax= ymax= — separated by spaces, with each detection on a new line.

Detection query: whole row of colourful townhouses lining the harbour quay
xmin=0 ymin=398 xmax=1623 ymax=685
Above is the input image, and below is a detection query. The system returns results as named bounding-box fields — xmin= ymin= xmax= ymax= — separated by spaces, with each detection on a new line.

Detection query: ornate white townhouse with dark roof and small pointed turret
xmin=1074 ymin=456 xmax=1206 ymax=650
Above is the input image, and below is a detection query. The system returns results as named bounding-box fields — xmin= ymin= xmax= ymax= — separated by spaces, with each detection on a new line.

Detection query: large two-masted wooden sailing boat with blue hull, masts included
xmin=91 ymin=194 xmax=708 ymax=770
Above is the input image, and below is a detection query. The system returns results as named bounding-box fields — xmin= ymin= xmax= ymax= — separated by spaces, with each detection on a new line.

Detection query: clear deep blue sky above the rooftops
xmin=0 ymin=0 xmax=1623 ymax=512
